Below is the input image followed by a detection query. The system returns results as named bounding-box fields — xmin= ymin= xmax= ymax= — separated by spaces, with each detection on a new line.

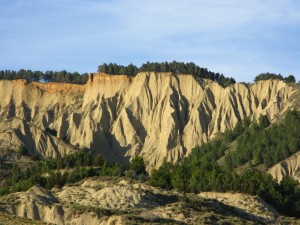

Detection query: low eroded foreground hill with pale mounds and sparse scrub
xmin=0 ymin=178 xmax=299 ymax=225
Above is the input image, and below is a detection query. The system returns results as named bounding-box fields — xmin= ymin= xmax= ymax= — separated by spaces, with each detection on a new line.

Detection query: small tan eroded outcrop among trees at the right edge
xmin=268 ymin=152 xmax=300 ymax=182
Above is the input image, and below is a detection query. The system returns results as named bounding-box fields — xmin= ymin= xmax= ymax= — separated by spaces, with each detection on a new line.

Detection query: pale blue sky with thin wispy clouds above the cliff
xmin=0 ymin=0 xmax=300 ymax=82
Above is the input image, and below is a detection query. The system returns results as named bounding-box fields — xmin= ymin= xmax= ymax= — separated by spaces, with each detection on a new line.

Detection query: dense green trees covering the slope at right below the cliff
xmin=150 ymin=111 xmax=300 ymax=217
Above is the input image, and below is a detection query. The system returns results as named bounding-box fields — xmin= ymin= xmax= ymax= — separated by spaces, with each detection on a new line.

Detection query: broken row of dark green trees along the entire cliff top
xmin=0 ymin=64 xmax=296 ymax=87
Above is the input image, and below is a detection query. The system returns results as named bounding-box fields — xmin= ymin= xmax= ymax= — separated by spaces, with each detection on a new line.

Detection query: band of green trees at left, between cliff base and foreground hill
xmin=0 ymin=150 xmax=146 ymax=195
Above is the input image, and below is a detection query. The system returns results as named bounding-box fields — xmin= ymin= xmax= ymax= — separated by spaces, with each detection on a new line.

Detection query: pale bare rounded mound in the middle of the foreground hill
xmin=56 ymin=179 xmax=157 ymax=210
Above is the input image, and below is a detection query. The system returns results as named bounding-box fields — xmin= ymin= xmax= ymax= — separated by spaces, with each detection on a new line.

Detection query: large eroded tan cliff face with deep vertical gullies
xmin=0 ymin=73 xmax=297 ymax=170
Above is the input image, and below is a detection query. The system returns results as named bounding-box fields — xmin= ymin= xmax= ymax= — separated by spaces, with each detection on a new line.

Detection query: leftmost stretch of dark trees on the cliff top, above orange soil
xmin=0 ymin=69 xmax=88 ymax=84
